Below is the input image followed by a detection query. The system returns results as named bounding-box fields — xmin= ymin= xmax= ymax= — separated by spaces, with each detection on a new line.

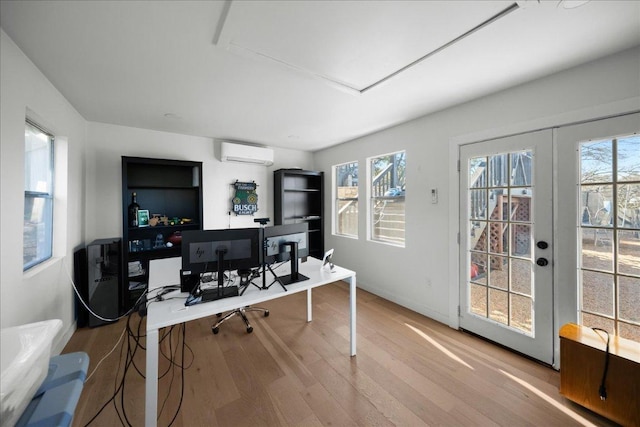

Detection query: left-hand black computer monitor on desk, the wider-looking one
xmin=181 ymin=228 xmax=262 ymax=294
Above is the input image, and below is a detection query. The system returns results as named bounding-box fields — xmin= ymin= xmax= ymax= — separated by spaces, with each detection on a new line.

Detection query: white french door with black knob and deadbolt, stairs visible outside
xmin=460 ymin=130 xmax=554 ymax=364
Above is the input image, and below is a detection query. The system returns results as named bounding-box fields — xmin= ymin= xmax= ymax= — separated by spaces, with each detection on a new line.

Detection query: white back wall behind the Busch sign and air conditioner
xmin=86 ymin=122 xmax=313 ymax=242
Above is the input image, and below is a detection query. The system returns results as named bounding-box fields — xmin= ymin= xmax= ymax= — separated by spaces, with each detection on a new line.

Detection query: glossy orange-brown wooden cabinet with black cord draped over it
xmin=560 ymin=323 xmax=640 ymax=426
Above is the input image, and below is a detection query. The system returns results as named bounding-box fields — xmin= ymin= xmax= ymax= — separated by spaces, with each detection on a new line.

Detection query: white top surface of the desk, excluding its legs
xmin=147 ymin=257 xmax=356 ymax=330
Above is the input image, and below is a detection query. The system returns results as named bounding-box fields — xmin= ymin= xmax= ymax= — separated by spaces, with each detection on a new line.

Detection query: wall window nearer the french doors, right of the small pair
xmin=369 ymin=151 xmax=406 ymax=246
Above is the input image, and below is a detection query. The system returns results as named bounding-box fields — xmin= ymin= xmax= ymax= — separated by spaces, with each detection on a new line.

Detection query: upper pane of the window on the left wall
xmin=24 ymin=124 xmax=53 ymax=194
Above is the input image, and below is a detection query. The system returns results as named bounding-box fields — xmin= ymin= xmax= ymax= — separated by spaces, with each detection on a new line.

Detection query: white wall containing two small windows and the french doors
xmin=315 ymin=48 xmax=640 ymax=326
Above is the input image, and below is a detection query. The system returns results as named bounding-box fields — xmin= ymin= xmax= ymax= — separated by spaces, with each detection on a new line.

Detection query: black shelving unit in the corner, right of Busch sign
xmin=273 ymin=169 xmax=324 ymax=259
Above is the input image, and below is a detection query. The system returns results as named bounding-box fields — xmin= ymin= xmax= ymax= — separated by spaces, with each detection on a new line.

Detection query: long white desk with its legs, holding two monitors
xmin=145 ymin=257 xmax=356 ymax=427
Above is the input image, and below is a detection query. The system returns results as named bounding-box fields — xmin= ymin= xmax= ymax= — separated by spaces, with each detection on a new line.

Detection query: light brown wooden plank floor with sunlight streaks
xmin=64 ymin=282 xmax=613 ymax=426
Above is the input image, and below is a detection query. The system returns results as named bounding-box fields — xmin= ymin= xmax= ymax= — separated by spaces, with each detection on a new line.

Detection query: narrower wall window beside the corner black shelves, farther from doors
xmin=333 ymin=162 xmax=358 ymax=237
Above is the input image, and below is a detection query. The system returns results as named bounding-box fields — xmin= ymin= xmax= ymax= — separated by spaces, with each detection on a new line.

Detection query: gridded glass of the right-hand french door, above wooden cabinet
xmin=578 ymin=135 xmax=640 ymax=341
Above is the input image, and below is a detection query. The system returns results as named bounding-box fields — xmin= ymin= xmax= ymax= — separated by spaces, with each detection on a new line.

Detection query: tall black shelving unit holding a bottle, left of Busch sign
xmin=120 ymin=156 xmax=202 ymax=312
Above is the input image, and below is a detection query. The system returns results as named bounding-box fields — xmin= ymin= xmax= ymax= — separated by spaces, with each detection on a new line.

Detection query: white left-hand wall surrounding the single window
xmin=0 ymin=30 xmax=86 ymax=352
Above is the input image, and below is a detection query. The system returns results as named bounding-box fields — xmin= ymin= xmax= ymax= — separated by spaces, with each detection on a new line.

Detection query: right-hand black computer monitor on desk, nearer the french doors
xmin=264 ymin=222 xmax=309 ymax=285
